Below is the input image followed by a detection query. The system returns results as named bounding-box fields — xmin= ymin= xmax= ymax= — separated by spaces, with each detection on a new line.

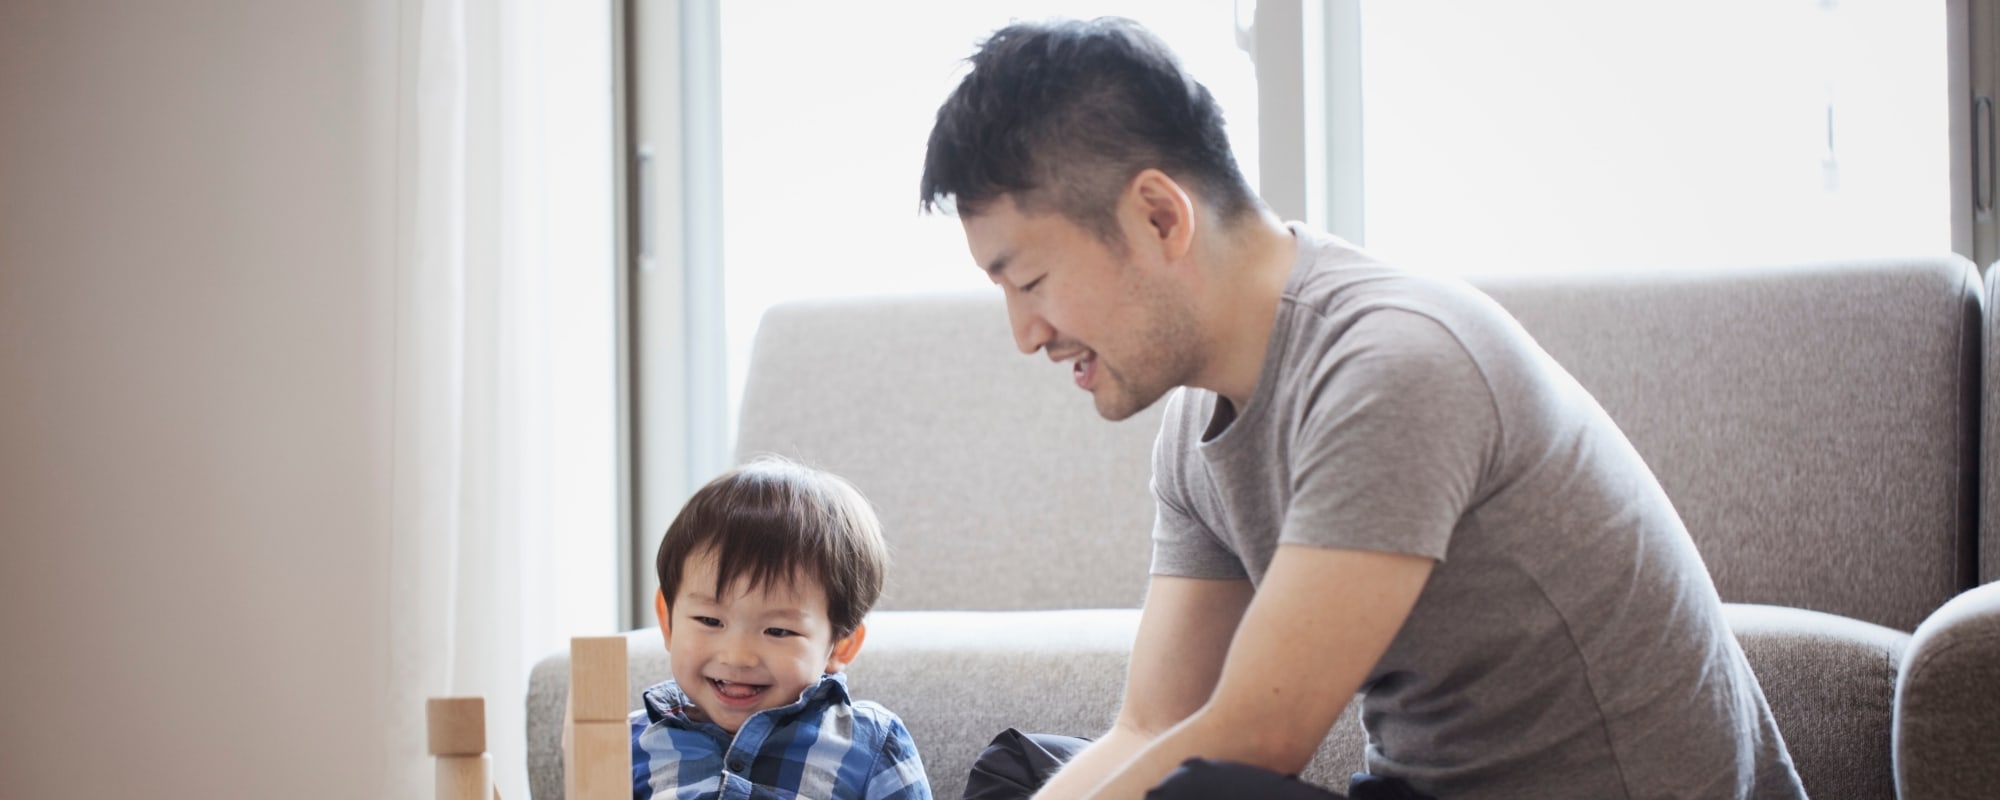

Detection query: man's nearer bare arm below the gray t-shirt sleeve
xmin=1088 ymin=544 xmax=1434 ymax=800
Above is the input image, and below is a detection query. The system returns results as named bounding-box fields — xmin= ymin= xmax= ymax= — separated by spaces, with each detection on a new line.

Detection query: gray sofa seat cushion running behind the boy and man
xmin=528 ymin=604 xmax=1910 ymax=800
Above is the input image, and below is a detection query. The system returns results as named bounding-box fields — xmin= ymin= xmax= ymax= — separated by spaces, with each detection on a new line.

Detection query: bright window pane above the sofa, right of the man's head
xmin=1360 ymin=0 xmax=1952 ymax=272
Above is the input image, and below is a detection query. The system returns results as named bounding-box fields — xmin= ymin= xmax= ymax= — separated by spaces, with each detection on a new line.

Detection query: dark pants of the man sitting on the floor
xmin=964 ymin=728 xmax=1432 ymax=800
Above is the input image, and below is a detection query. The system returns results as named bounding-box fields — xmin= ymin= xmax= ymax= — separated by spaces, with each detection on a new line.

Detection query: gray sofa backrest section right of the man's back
xmin=1474 ymin=256 xmax=1982 ymax=630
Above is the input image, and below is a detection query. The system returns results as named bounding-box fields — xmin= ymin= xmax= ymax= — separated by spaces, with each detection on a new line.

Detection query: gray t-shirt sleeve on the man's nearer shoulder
xmin=1278 ymin=310 xmax=1500 ymax=560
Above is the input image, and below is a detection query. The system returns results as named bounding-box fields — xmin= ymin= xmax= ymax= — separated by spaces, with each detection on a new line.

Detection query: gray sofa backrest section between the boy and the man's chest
xmin=736 ymin=290 xmax=1160 ymax=612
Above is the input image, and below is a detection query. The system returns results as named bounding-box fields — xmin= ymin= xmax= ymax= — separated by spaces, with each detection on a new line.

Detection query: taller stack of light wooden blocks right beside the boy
xmin=564 ymin=636 xmax=632 ymax=800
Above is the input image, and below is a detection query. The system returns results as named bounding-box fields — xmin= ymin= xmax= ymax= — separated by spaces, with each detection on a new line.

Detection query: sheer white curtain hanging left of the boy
xmin=386 ymin=0 xmax=620 ymax=798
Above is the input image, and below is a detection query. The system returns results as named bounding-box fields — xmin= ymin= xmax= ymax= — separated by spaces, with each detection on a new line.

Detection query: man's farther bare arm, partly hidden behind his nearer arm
xmin=1036 ymin=576 xmax=1250 ymax=800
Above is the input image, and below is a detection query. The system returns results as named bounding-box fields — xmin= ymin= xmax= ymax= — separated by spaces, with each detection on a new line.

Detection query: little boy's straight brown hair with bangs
xmin=654 ymin=456 xmax=888 ymax=642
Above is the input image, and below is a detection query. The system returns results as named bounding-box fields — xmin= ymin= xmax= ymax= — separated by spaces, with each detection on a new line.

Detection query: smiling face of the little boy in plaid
xmin=660 ymin=548 xmax=844 ymax=732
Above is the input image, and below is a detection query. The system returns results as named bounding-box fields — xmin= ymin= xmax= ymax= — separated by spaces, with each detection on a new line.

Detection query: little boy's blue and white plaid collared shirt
xmin=632 ymin=674 xmax=930 ymax=800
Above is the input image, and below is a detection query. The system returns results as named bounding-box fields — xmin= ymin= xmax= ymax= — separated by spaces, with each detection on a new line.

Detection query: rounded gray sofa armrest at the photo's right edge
xmin=1894 ymin=582 xmax=2000 ymax=800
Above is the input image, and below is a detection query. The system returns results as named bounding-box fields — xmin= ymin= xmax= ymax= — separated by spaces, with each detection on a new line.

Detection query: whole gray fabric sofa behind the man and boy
xmin=528 ymin=258 xmax=2000 ymax=800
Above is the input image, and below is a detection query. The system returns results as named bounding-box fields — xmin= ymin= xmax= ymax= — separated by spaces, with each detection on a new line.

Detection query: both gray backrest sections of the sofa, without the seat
xmin=738 ymin=258 xmax=1982 ymax=630
